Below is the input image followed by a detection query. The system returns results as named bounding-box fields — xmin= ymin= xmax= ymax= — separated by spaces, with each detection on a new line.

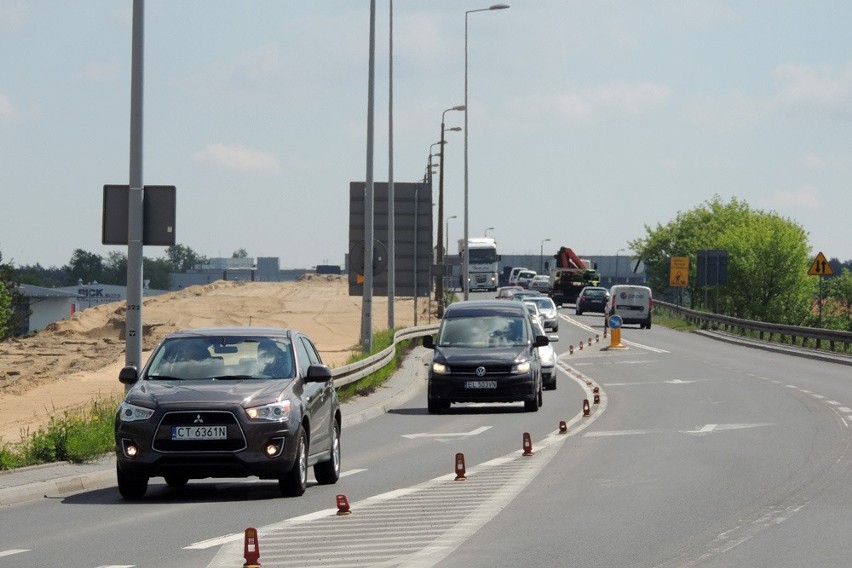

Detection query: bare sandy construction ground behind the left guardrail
xmin=0 ymin=274 xmax=426 ymax=444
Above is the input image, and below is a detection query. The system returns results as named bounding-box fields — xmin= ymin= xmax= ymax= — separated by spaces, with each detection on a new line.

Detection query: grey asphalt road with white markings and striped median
xmin=0 ymin=304 xmax=852 ymax=567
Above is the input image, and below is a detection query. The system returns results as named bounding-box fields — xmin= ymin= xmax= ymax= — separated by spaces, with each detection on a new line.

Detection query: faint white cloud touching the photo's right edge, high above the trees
xmin=774 ymin=63 xmax=852 ymax=115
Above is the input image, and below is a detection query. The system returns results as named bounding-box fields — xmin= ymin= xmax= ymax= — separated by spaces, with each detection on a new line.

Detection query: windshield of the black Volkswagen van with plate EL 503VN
xmin=437 ymin=315 xmax=530 ymax=348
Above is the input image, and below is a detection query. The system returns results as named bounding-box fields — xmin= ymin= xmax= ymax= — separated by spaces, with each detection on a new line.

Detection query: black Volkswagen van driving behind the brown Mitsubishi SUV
xmin=423 ymin=300 xmax=549 ymax=414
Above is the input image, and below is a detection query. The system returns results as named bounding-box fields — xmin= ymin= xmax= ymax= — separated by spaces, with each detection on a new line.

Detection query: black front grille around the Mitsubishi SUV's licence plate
xmin=152 ymin=411 xmax=246 ymax=452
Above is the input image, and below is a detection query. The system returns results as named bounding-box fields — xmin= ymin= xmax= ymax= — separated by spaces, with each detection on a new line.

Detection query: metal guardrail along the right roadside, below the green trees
xmin=654 ymin=299 xmax=852 ymax=353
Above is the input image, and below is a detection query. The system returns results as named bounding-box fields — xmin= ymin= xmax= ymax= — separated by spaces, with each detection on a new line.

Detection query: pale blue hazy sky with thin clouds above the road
xmin=0 ymin=0 xmax=852 ymax=268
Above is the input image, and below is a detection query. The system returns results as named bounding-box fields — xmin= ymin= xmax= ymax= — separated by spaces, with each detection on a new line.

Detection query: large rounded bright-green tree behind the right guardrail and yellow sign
xmin=629 ymin=196 xmax=815 ymax=324
